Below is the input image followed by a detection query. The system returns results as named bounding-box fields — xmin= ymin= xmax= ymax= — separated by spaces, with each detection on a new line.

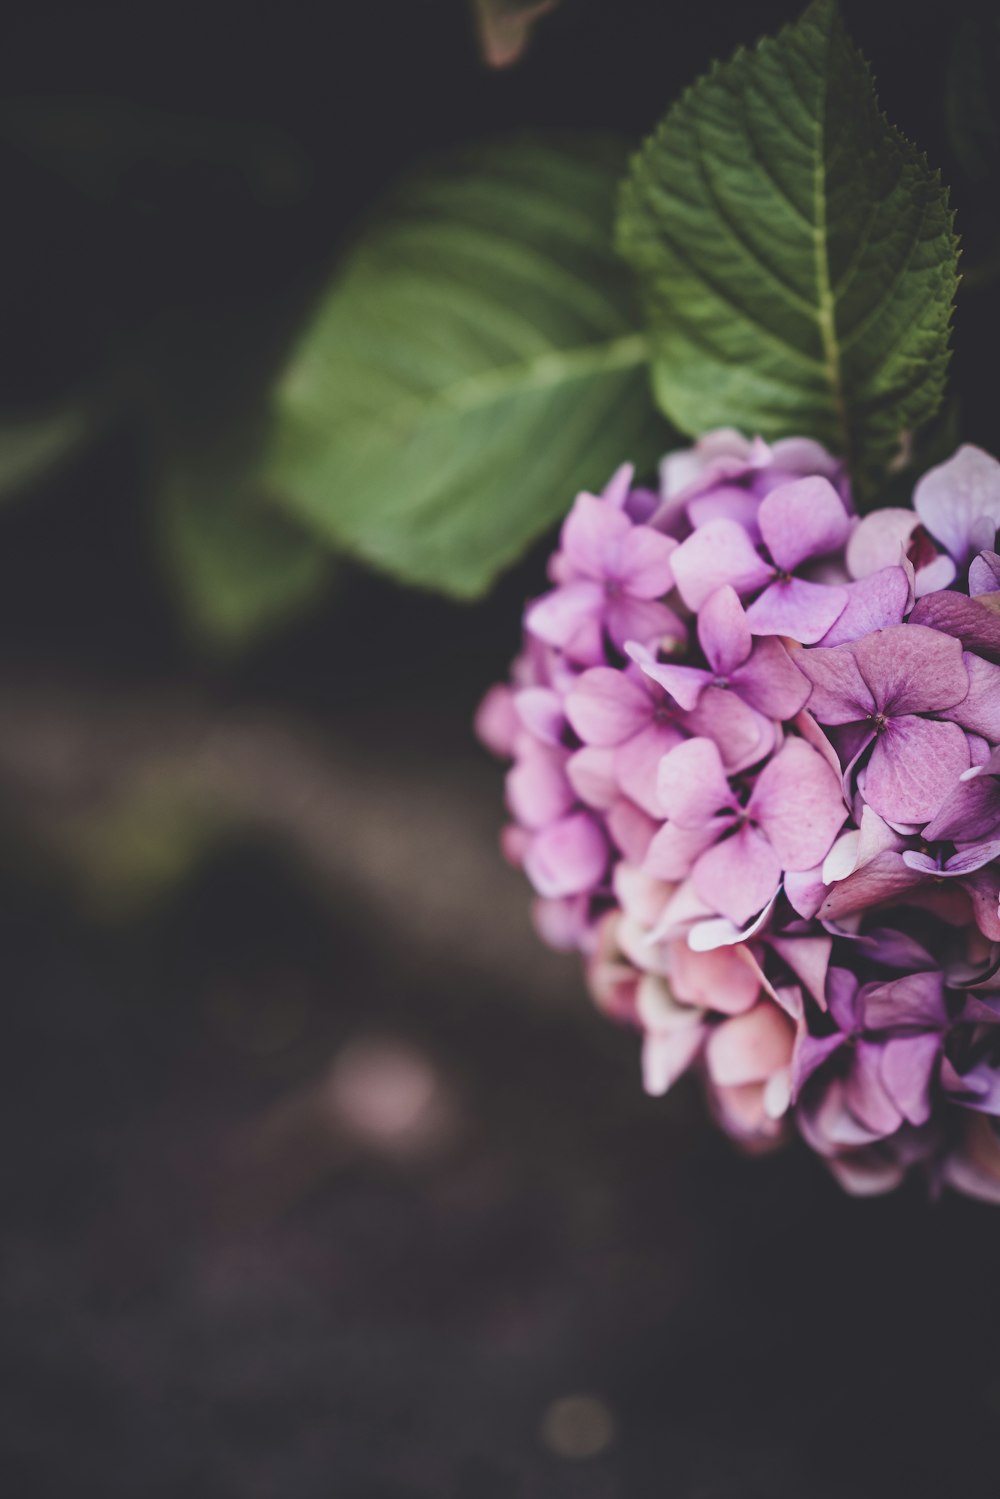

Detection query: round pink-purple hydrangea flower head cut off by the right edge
xmin=477 ymin=432 xmax=1000 ymax=1201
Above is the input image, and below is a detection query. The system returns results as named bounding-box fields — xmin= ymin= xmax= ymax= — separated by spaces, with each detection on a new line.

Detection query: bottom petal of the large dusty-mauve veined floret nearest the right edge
xmin=859 ymin=715 xmax=969 ymax=823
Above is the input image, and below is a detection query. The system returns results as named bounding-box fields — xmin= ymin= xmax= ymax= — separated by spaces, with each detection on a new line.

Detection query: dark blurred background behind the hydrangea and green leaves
xmin=0 ymin=0 xmax=1000 ymax=1499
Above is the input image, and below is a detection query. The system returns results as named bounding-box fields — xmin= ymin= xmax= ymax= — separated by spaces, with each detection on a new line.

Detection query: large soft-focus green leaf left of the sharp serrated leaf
xmin=267 ymin=139 xmax=664 ymax=598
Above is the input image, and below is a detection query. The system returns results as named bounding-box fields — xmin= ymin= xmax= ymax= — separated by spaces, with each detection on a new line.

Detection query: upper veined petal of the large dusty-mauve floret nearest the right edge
xmin=851 ymin=622 xmax=969 ymax=717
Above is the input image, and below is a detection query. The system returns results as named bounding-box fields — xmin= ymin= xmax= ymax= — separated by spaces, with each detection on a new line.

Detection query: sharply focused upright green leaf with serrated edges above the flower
xmin=618 ymin=0 xmax=957 ymax=480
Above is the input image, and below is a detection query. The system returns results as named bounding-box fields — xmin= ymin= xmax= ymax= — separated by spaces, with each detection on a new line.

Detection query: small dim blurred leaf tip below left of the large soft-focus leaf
xmin=162 ymin=472 xmax=330 ymax=646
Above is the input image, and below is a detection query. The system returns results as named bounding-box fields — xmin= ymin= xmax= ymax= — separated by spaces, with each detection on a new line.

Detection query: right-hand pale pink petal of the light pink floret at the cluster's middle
xmin=747 ymin=739 xmax=847 ymax=869
